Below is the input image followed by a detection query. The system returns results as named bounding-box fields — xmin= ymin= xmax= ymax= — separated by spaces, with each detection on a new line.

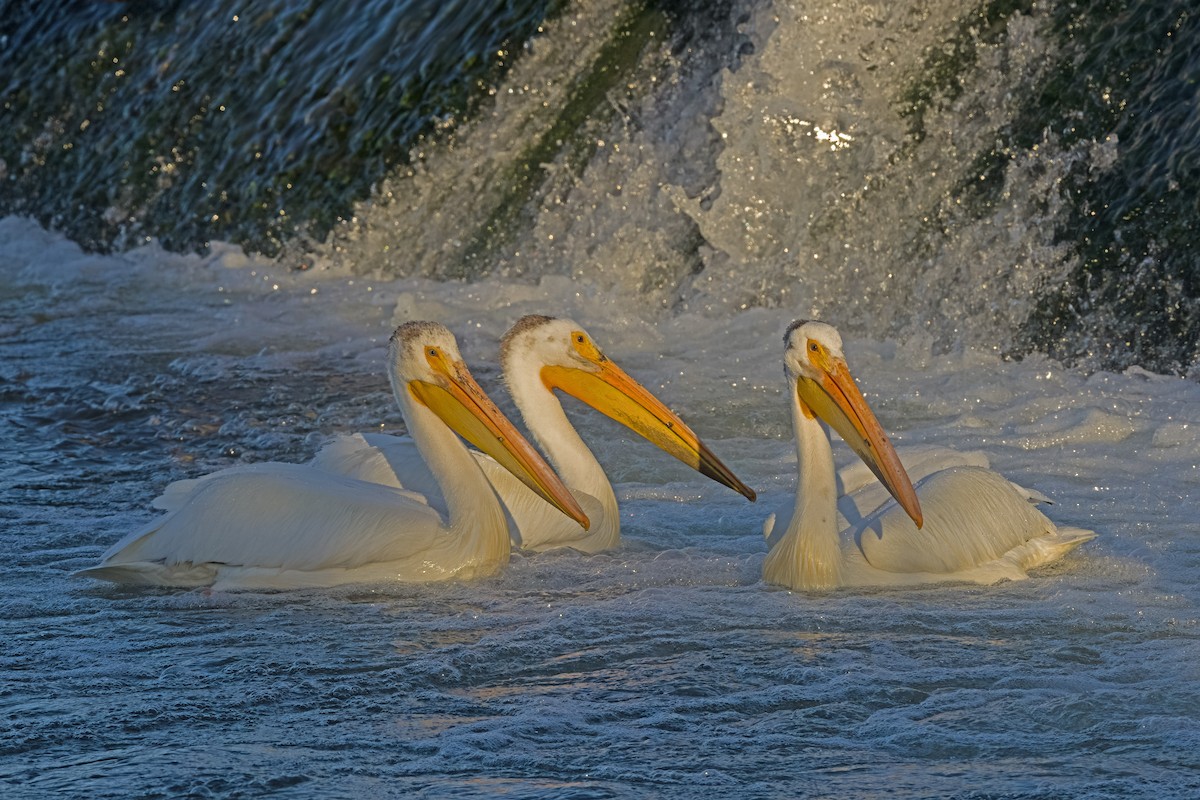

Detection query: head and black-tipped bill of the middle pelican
xmin=500 ymin=314 xmax=755 ymax=500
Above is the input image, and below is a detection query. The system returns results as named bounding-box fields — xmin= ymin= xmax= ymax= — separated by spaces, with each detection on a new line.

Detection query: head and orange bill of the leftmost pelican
xmin=388 ymin=321 xmax=589 ymax=528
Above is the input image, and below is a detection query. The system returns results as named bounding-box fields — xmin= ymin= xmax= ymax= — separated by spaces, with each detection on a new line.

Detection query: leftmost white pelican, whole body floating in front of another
xmin=72 ymin=323 xmax=588 ymax=588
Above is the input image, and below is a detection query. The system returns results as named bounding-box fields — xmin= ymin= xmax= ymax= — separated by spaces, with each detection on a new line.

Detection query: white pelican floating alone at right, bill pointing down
xmin=763 ymin=320 xmax=1096 ymax=589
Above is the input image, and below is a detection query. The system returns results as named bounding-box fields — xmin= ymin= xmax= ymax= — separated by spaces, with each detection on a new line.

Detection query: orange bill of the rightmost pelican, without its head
xmin=796 ymin=356 xmax=924 ymax=528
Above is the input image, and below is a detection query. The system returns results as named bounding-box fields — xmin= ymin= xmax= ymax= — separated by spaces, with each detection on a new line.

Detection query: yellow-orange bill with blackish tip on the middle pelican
xmin=541 ymin=338 xmax=756 ymax=500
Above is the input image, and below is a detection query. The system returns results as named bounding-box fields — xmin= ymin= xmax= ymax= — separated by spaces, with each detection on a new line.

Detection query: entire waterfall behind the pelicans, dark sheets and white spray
xmin=0 ymin=0 xmax=1200 ymax=372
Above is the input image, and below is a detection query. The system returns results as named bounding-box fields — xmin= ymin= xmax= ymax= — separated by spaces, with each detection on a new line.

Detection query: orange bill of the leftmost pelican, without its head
xmin=408 ymin=356 xmax=590 ymax=530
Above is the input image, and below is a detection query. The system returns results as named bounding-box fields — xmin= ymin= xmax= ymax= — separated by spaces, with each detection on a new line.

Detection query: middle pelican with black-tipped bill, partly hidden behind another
xmin=314 ymin=314 xmax=755 ymax=553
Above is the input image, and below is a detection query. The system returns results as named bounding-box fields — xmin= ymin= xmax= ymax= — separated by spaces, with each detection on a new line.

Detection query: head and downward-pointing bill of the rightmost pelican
xmin=784 ymin=320 xmax=923 ymax=528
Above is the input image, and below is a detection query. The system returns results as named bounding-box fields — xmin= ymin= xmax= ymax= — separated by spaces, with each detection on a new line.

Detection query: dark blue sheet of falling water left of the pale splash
xmin=0 ymin=0 xmax=556 ymax=253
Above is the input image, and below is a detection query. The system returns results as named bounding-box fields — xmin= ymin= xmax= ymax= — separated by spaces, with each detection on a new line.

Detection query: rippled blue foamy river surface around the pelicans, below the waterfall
xmin=0 ymin=219 xmax=1200 ymax=798
